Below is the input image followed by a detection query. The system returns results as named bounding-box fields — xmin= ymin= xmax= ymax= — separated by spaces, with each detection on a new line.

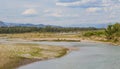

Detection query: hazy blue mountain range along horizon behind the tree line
xmin=0 ymin=21 xmax=109 ymax=28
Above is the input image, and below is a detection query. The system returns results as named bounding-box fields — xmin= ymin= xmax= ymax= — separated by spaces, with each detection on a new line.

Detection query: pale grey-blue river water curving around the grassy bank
xmin=18 ymin=41 xmax=120 ymax=69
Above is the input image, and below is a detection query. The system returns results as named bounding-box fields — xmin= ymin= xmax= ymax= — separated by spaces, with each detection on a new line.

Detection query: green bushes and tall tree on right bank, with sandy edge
xmin=83 ymin=23 xmax=120 ymax=44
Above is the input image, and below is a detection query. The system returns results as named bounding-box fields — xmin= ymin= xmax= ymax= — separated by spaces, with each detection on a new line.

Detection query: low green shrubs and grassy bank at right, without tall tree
xmin=82 ymin=30 xmax=120 ymax=45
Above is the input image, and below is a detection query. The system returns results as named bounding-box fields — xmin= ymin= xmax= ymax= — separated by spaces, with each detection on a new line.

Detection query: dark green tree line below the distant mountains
xmin=0 ymin=26 xmax=98 ymax=34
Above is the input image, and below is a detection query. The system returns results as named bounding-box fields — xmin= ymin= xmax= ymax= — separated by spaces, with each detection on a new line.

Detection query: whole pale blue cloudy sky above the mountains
xmin=0 ymin=0 xmax=120 ymax=26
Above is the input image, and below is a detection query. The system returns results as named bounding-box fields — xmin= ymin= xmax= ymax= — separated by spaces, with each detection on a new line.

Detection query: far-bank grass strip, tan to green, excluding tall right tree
xmin=0 ymin=30 xmax=120 ymax=45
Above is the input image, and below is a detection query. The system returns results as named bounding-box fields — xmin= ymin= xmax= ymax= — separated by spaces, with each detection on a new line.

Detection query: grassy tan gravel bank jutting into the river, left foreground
xmin=0 ymin=43 xmax=67 ymax=69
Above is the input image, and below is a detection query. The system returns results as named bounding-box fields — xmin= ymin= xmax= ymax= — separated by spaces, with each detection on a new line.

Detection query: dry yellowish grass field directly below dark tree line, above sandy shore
xmin=0 ymin=32 xmax=78 ymax=39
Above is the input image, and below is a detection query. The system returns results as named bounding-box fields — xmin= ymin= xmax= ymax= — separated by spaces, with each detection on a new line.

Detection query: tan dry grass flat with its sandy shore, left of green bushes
xmin=0 ymin=32 xmax=80 ymax=42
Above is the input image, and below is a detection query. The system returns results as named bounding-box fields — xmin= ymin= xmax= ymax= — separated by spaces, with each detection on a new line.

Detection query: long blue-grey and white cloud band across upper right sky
xmin=56 ymin=0 xmax=120 ymax=12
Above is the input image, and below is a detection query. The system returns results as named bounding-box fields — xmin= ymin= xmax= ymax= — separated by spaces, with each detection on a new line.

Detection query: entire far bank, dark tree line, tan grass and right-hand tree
xmin=0 ymin=23 xmax=120 ymax=42
